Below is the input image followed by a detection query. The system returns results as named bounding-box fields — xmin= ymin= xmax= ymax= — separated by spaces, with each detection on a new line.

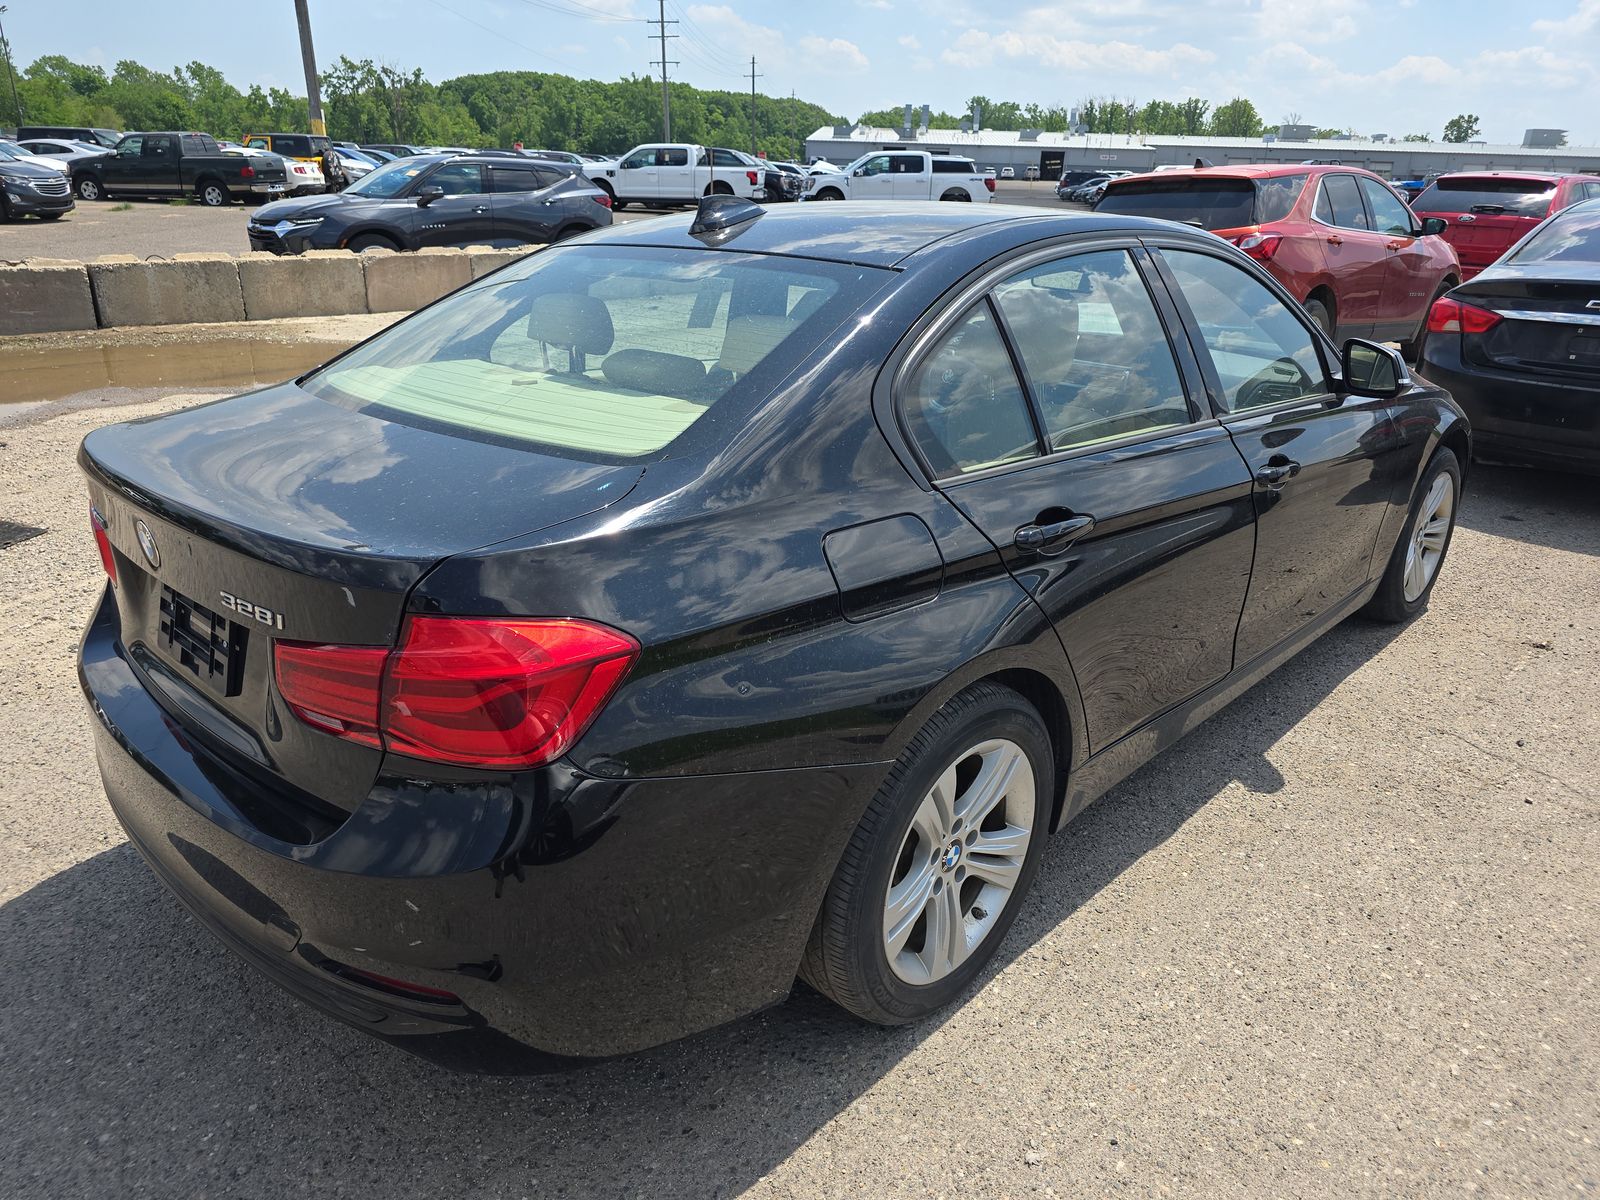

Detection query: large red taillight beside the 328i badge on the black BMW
xmin=277 ymin=616 xmax=638 ymax=768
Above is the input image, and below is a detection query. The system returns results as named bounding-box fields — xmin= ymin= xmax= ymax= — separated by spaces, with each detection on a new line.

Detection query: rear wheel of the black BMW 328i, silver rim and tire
xmin=800 ymin=683 xmax=1054 ymax=1026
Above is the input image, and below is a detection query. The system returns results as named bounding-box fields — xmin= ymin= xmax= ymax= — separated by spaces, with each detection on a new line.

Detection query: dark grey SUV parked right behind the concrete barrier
xmin=246 ymin=154 xmax=611 ymax=254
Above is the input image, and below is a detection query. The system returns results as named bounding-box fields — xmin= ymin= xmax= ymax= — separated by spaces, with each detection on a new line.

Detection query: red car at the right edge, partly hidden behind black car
xmin=1411 ymin=171 xmax=1600 ymax=280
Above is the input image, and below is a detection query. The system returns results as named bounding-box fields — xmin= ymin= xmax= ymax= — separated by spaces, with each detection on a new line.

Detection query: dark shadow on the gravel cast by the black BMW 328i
xmin=0 ymin=621 xmax=1397 ymax=1197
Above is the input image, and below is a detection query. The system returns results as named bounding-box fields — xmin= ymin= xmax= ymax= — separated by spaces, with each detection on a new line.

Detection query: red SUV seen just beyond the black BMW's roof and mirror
xmin=1094 ymin=165 xmax=1461 ymax=357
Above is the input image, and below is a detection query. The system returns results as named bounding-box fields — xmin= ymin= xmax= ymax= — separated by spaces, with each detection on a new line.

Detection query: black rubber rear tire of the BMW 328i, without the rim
xmin=800 ymin=683 xmax=1056 ymax=1026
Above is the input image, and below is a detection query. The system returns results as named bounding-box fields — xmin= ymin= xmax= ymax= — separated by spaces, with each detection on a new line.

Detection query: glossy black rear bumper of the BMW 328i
xmin=78 ymin=590 xmax=888 ymax=1072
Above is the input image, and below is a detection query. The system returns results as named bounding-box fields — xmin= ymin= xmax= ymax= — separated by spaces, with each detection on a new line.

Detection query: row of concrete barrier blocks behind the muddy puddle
xmin=0 ymin=246 xmax=541 ymax=336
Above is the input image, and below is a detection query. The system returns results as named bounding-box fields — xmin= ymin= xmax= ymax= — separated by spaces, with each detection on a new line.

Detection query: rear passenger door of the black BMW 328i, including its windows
xmin=901 ymin=246 xmax=1254 ymax=752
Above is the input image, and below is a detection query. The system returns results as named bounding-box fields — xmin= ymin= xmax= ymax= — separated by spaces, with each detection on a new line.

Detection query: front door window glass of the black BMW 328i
xmin=1162 ymin=246 xmax=1331 ymax=413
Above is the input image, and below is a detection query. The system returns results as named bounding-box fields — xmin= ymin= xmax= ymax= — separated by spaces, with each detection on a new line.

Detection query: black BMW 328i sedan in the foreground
xmin=80 ymin=197 xmax=1470 ymax=1070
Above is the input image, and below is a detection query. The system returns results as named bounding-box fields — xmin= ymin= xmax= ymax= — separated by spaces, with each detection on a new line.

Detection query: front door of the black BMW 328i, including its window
xmin=1160 ymin=240 xmax=1403 ymax=666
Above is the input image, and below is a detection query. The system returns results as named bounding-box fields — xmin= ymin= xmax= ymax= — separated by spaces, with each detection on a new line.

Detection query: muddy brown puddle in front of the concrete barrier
xmin=0 ymin=339 xmax=346 ymax=405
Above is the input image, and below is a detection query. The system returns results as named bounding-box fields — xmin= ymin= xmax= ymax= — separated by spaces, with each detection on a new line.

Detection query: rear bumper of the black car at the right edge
xmin=1418 ymin=334 xmax=1600 ymax=474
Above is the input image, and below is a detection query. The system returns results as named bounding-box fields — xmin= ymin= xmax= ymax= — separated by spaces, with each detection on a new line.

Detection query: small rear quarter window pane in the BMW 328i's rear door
xmin=902 ymin=301 xmax=1038 ymax=475
